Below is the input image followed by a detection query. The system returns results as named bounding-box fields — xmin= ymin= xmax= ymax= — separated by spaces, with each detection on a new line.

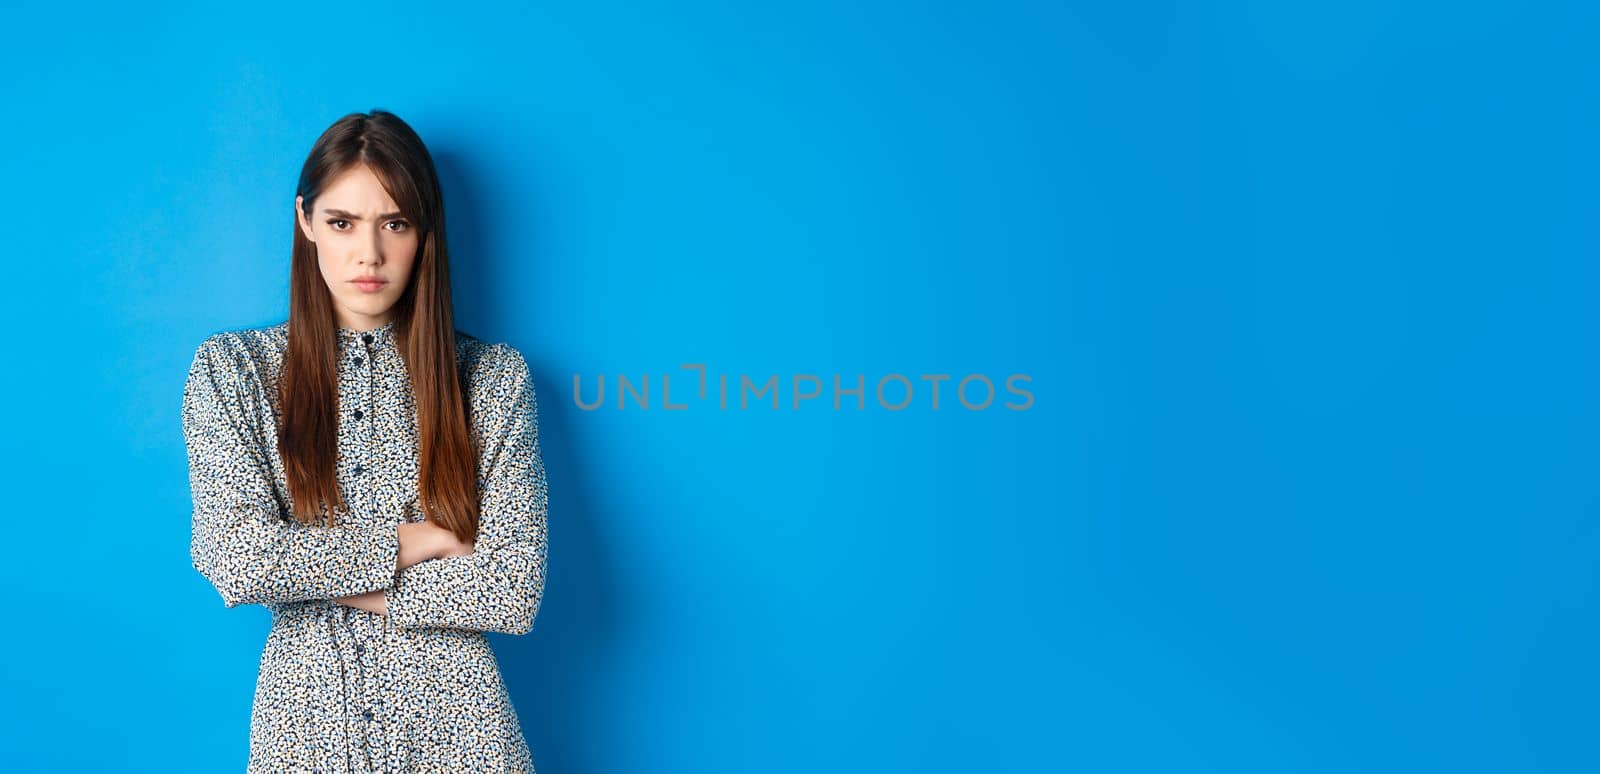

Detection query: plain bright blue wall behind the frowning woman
xmin=0 ymin=0 xmax=1600 ymax=774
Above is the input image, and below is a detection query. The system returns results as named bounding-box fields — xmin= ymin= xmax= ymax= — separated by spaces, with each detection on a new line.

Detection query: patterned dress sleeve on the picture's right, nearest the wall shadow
xmin=384 ymin=344 xmax=549 ymax=635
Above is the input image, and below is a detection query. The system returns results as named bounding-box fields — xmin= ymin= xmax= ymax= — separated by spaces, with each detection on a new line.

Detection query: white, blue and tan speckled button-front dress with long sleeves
xmin=182 ymin=321 xmax=547 ymax=772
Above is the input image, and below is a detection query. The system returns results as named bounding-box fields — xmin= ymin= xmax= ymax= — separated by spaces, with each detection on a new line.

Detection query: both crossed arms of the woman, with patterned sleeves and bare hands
xmin=182 ymin=334 xmax=547 ymax=635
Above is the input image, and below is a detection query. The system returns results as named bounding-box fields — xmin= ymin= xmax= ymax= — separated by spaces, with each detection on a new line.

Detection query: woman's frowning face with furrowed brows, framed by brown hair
xmin=294 ymin=165 xmax=418 ymax=331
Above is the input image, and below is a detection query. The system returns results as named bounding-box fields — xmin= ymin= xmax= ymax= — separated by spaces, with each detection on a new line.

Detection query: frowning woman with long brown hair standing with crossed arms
xmin=182 ymin=110 xmax=546 ymax=772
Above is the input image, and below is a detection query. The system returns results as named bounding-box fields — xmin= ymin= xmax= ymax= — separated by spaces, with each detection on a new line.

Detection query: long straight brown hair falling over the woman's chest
xmin=278 ymin=110 xmax=478 ymax=541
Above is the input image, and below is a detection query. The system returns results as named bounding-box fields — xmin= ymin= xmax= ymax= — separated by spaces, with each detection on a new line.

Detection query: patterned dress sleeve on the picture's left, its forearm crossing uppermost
xmin=182 ymin=334 xmax=400 ymax=608
